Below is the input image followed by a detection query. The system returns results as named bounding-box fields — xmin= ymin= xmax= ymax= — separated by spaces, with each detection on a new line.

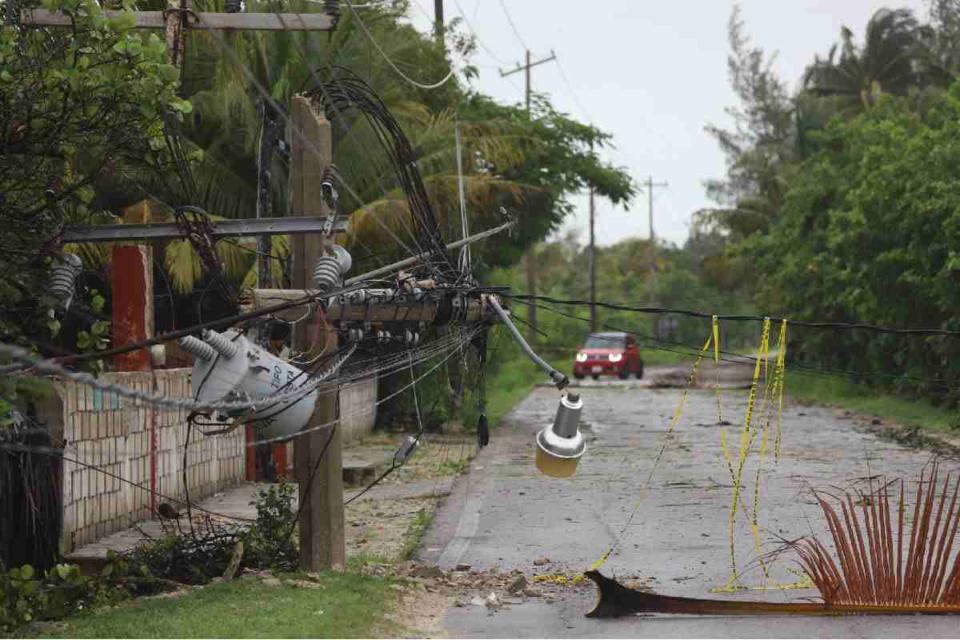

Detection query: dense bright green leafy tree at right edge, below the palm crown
xmin=743 ymin=87 xmax=960 ymax=402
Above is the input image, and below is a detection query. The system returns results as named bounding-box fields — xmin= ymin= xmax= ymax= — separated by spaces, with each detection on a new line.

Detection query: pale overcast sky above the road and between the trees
xmin=412 ymin=0 xmax=926 ymax=244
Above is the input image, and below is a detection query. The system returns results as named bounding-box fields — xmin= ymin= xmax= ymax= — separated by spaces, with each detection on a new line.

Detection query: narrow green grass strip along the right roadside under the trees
xmin=785 ymin=373 xmax=960 ymax=433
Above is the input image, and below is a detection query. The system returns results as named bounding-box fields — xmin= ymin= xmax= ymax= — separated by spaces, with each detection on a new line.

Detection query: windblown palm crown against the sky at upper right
xmin=804 ymin=9 xmax=923 ymax=111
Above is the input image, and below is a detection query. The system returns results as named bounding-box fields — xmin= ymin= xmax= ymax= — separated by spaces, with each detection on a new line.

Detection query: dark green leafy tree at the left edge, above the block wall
xmin=0 ymin=0 xmax=184 ymax=348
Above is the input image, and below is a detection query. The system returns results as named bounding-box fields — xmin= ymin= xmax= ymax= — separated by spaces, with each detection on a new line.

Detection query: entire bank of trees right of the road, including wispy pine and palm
xmin=697 ymin=0 xmax=960 ymax=406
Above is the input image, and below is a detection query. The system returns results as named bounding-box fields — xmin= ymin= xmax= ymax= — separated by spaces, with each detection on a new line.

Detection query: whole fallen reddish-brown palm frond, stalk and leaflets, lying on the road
xmin=586 ymin=463 xmax=960 ymax=617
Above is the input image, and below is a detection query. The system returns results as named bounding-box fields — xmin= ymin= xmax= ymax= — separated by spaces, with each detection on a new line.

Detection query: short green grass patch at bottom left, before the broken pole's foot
xmin=33 ymin=573 xmax=403 ymax=638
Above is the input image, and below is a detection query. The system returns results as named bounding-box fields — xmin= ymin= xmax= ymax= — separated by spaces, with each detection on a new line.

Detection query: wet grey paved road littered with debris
xmin=420 ymin=382 xmax=960 ymax=637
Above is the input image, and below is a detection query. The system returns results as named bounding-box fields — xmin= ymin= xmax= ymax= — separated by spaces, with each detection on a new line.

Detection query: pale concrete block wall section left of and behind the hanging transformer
xmin=52 ymin=369 xmax=244 ymax=553
